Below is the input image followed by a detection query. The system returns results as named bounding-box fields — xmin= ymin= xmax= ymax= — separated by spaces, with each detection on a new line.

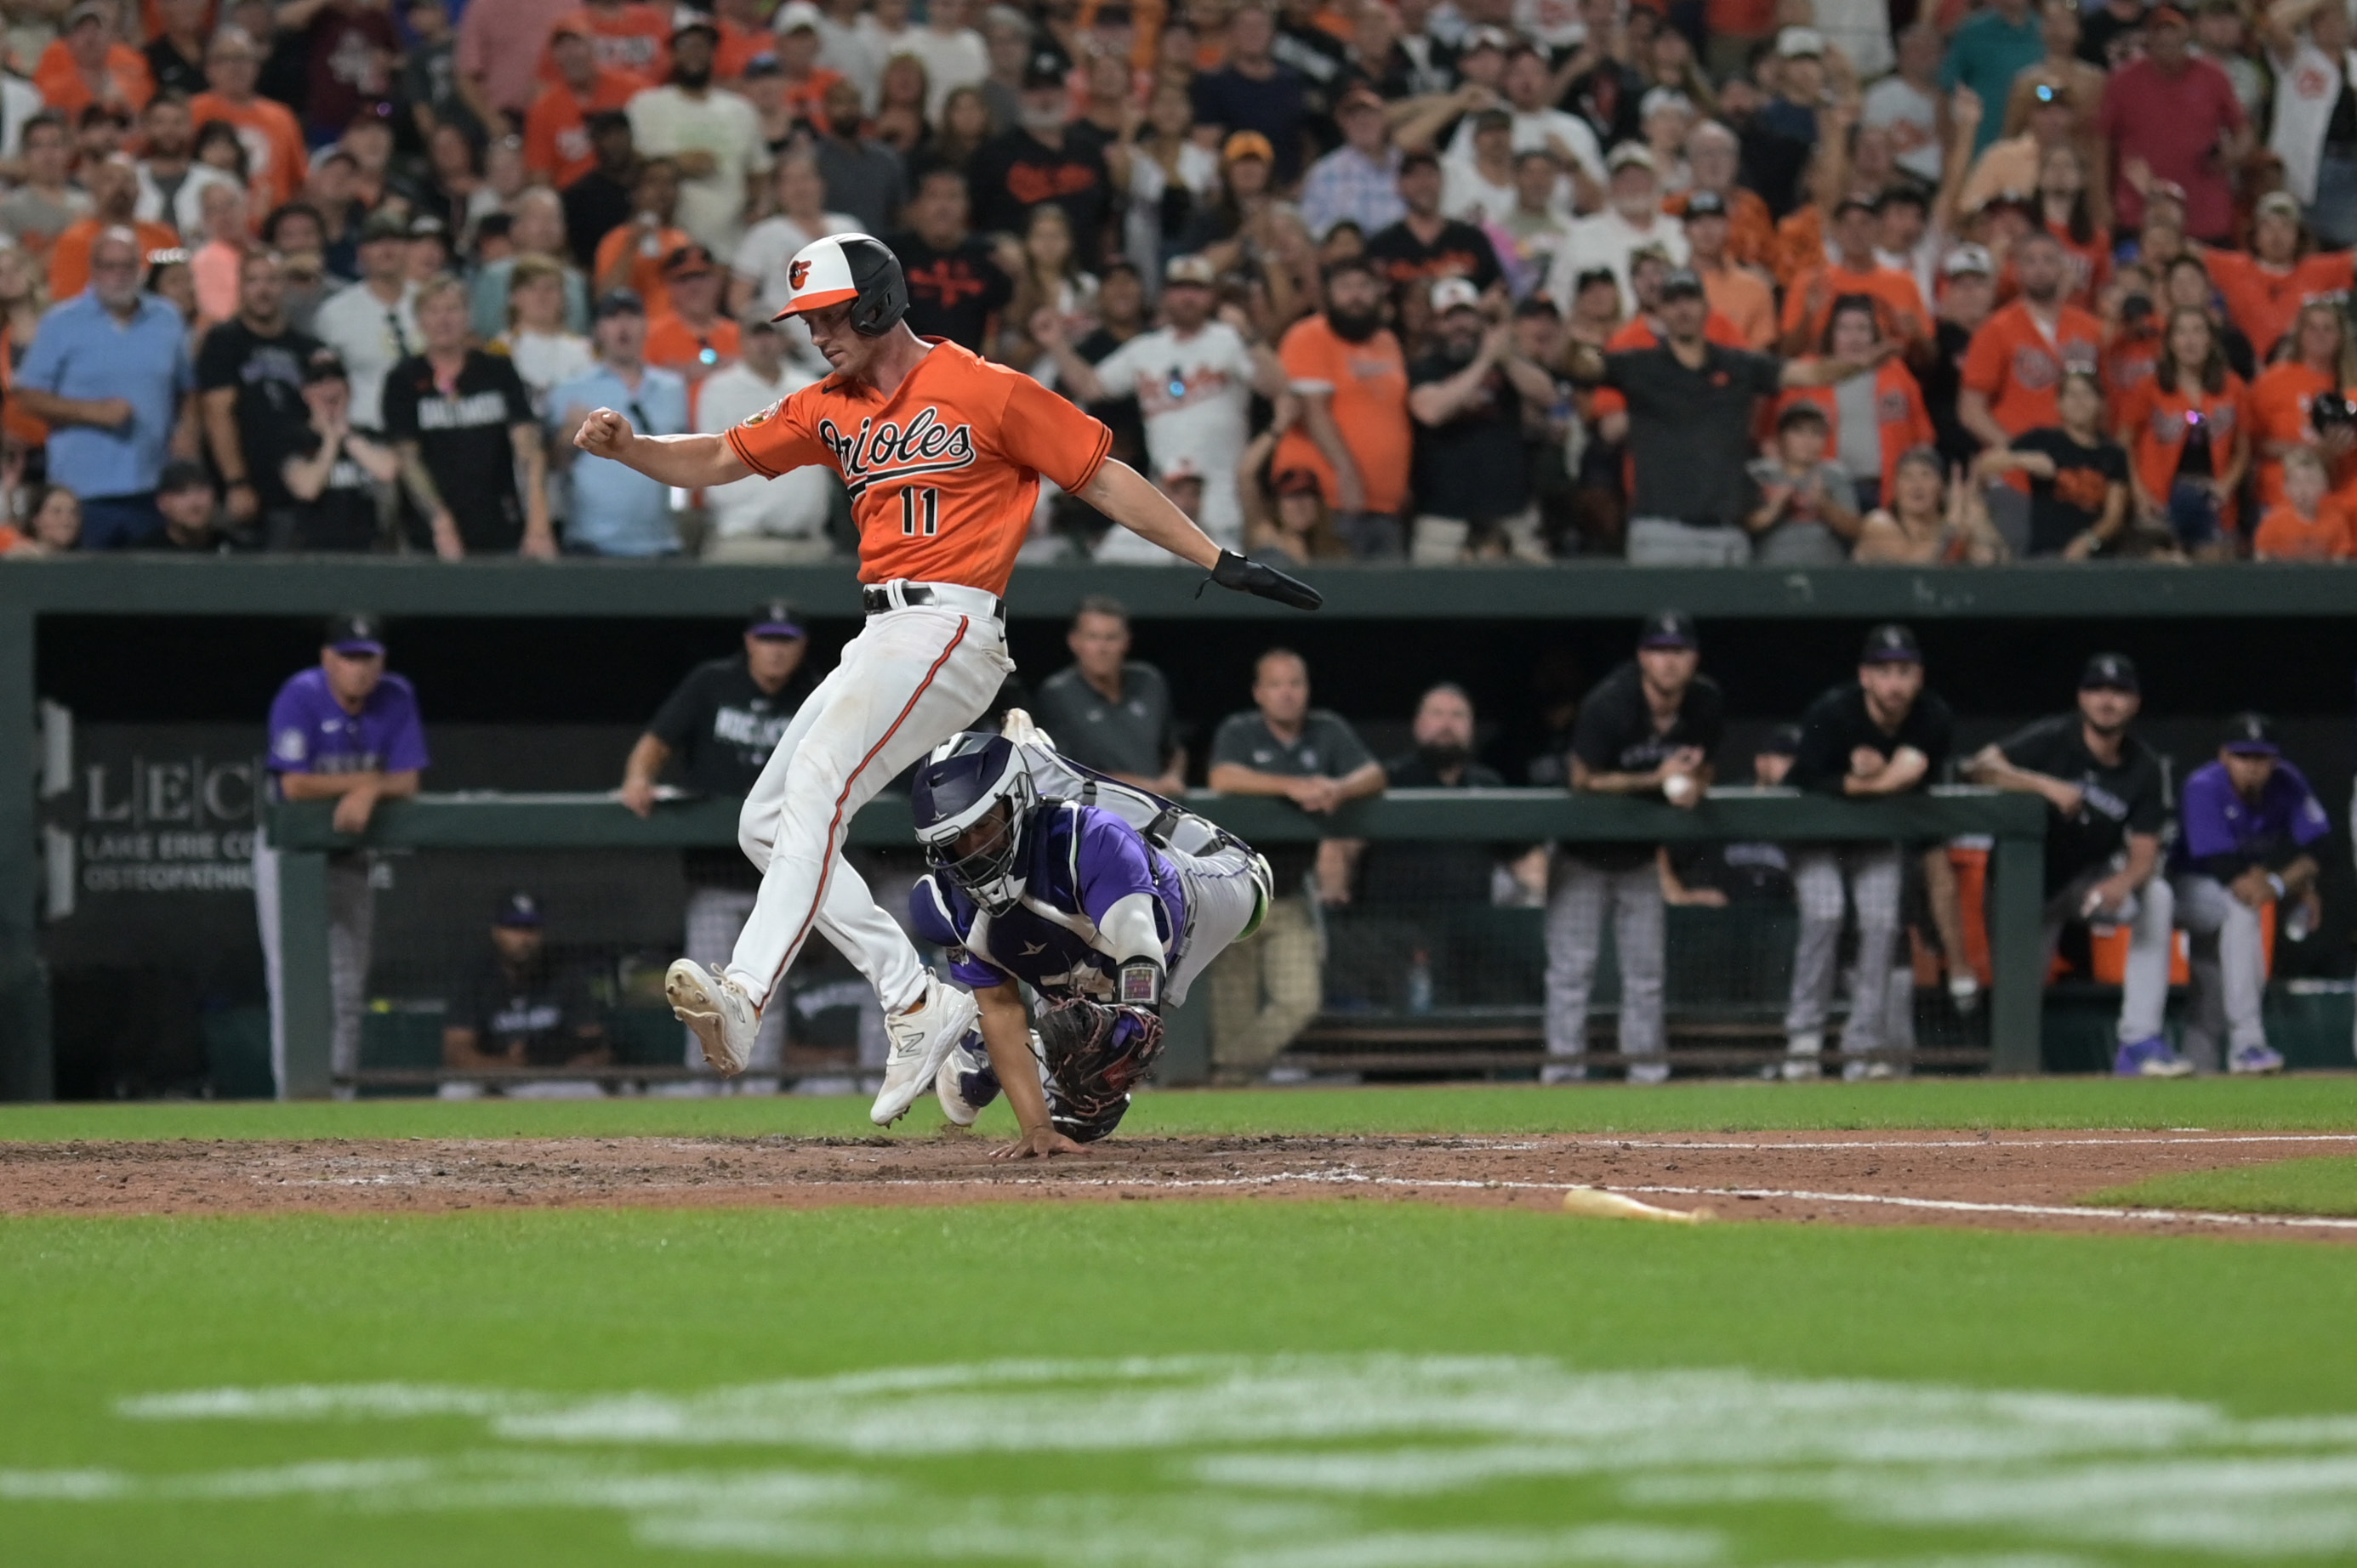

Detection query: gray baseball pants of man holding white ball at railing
xmin=1546 ymin=854 xmax=1666 ymax=1065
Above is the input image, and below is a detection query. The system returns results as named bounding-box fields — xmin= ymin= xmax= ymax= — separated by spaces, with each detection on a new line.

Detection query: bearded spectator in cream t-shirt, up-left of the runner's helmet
xmin=629 ymin=12 xmax=771 ymax=262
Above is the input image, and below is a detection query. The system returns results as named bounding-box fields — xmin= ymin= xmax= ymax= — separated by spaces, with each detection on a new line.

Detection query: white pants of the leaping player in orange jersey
xmin=728 ymin=589 xmax=1016 ymax=1012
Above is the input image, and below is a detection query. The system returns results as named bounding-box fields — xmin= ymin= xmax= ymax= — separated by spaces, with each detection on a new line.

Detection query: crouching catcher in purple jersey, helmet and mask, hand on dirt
xmin=910 ymin=714 xmax=1271 ymax=1158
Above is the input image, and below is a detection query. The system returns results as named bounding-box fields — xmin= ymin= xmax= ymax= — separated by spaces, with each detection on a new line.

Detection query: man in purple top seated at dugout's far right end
xmin=2171 ymin=712 xmax=2331 ymax=1073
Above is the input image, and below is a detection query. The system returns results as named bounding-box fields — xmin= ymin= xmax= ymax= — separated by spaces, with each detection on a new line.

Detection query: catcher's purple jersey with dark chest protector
xmin=908 ymin=802 xmax=1188 ymax=1004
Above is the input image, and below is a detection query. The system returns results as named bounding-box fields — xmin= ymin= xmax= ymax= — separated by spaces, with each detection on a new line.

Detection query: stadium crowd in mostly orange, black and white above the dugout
xmin=0 ymin=0 xmax=2357 ymax=566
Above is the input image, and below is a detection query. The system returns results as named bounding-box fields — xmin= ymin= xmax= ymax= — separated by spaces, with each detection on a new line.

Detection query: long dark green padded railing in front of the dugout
xmin=269 ymin=787 xmax=2046 ymax=1096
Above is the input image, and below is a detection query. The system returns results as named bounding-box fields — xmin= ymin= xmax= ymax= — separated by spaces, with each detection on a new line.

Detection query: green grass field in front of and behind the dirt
xmin=0 ymin=1080 xmax=2357 ymax=1568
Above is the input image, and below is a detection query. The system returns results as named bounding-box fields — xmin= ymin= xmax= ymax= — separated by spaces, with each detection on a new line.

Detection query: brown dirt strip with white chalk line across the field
xmin=0 ymin=1132 xmax=2357 ymax=1241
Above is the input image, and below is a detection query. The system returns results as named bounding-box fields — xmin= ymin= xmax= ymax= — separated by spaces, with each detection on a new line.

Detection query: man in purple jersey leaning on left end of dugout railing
xmin=254 ymin=616 xmax=429 ymax=1099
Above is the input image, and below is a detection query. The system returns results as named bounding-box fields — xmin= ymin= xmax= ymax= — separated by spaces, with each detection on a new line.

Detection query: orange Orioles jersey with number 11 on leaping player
xmin=728 ymin=338 xmax=1113 ymax=594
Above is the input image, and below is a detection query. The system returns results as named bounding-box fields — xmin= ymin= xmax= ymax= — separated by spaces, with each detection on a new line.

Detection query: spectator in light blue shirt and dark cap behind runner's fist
xmin=549 ymin=287 xmax=688 ymax=556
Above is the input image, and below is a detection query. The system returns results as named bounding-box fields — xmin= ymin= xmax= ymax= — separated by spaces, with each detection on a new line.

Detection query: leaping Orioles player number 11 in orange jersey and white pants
xmin=572 ymin=234 xmax=1320 ymax=1127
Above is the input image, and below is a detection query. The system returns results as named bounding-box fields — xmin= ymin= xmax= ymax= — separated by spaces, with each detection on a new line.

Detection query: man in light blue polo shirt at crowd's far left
xmin=16 ymin=229 xmax=196 ymax=549
